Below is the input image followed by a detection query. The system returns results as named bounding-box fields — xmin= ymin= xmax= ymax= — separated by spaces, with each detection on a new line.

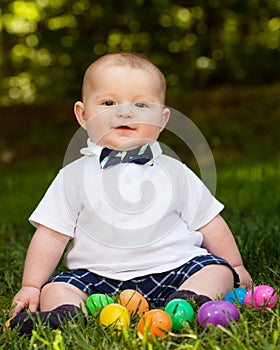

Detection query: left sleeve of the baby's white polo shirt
xmin=29 ymin=170 xmax=77 ymax=237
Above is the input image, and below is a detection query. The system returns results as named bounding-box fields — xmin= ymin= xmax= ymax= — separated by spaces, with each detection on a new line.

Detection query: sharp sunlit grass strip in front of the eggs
xmin=2 ymin=310 xmax=280 ymax=350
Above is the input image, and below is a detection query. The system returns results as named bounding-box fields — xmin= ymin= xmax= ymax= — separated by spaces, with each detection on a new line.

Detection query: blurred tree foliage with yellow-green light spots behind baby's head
xmin=0 ymin=0 xmax=280 ymax=106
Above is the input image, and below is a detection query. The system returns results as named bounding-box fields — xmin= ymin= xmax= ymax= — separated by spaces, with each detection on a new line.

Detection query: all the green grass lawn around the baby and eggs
xmin=0 ymin=164 xmax=280 ymax=350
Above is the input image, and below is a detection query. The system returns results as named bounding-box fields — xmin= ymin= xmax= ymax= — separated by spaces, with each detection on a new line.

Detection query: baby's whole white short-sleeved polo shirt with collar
xmin=29 ymin=141 xmax=223 ymax=280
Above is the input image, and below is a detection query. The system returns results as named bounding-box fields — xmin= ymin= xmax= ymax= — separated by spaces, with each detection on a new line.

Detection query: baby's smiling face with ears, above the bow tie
xmin=75 ymin=65 xmax=170 ymax=150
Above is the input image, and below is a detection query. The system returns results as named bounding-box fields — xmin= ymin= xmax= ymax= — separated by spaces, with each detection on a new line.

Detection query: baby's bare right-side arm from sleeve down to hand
xmin=198 ymin=215 xmax=252 ymax=289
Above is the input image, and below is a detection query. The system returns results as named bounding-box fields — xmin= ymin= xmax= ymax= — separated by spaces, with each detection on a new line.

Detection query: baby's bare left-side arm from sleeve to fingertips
xmin=12 ymin=225 xmax=69 ymax=317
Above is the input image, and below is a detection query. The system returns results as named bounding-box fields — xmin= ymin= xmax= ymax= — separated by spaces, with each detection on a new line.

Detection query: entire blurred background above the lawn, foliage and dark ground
xmin=0 ymin=0 xmax=280 ymax=166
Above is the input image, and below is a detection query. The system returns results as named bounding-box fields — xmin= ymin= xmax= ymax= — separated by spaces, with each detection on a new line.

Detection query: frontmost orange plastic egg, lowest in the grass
xmin=137 ymin=309 xmax=172 ymax=339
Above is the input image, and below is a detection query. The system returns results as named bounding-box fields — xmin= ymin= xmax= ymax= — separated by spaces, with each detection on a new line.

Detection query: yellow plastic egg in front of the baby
xmin=99 ymin=303 xmax=130 ymax=330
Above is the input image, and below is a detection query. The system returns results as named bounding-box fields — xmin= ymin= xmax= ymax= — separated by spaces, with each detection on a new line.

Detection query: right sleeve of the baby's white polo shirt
xmin=182 ymin=166 xmax=224 ymax=231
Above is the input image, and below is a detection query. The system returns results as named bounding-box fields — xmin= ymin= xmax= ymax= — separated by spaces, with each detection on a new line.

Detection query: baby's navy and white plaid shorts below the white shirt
xmin=46 ymin=254 xmax=240 ymax=307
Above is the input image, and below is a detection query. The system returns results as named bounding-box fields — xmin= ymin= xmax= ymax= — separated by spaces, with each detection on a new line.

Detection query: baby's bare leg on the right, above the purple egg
xmin=178 ymin=265 xmax=234 ymax=299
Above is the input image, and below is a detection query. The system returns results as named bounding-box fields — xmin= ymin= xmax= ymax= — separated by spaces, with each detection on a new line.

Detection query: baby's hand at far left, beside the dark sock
xmin=11 ymin=286 xmax=40 ymax=318
